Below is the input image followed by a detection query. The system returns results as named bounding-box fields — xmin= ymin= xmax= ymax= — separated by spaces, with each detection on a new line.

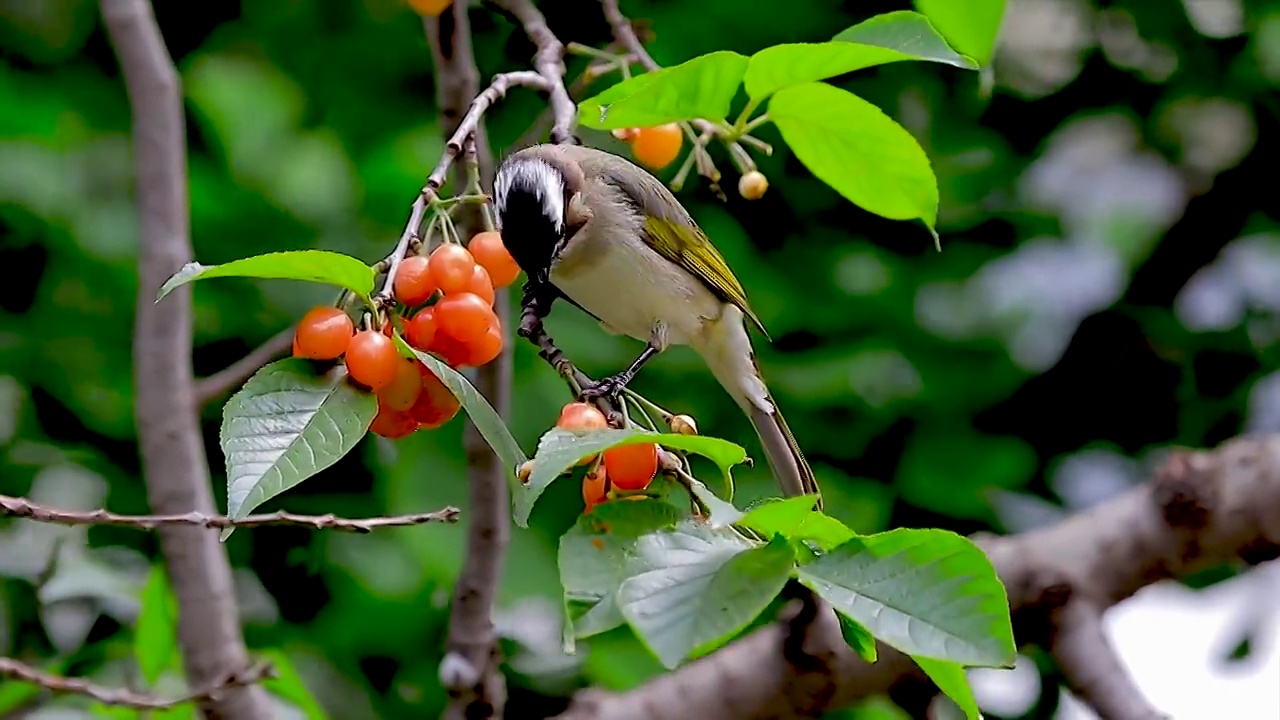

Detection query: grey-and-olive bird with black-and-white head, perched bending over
xmin=494 ymin=145 xmax=822 ymax=506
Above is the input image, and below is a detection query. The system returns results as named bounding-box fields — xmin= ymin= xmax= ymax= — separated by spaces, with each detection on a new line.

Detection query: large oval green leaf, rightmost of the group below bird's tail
xmin=799 ymin=529 xmax=1016 ymax=667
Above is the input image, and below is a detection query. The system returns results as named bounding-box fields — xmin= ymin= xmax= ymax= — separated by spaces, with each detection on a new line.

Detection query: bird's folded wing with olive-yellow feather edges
xmin=599 ymin=158 xmax=769 ymax=337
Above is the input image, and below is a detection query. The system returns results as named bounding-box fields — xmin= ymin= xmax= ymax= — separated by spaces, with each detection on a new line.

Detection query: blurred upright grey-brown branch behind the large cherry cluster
xmin=425 ymin=3 xmax=509 ymax=720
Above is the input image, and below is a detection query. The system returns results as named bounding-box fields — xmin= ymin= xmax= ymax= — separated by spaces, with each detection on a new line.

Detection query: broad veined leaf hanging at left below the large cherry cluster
xmin=221 ymin=357 xmax=378 ymax=539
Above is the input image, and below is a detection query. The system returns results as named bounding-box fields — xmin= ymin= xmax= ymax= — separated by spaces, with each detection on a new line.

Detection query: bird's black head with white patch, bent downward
xmin=493 ymin=145 xmax=582 ymax=281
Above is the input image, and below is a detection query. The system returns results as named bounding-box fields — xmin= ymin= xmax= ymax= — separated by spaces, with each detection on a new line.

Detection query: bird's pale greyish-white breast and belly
xmin=550 ymin=227 xmax=724 ymax=345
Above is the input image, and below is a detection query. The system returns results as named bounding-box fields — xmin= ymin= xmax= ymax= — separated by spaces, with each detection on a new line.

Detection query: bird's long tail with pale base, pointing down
xmin=694 ymin=311 xmax=822 ymax=510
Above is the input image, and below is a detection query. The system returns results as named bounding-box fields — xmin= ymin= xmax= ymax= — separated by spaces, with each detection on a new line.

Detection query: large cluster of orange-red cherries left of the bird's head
xmin=293 ymin=231 xmax=520 ymax=439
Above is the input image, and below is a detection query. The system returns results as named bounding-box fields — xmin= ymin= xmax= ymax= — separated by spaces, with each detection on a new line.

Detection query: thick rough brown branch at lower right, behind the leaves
xmin=561 ymin=436 xmax=1280 ymax=720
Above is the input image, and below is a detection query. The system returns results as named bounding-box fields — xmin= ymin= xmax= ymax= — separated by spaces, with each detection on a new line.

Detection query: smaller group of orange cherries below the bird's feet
xmin=556 ymin=402 xmax=658 ymax=512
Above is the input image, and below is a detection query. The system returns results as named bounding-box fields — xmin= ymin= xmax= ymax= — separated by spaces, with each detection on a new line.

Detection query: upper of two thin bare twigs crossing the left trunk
xmin=0 ymin=495 xmax=458 ymax=533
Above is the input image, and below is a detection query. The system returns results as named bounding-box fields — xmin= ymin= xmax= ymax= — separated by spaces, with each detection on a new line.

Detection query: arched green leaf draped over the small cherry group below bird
xmin=515 ymin=428 xmax=746 ymax=528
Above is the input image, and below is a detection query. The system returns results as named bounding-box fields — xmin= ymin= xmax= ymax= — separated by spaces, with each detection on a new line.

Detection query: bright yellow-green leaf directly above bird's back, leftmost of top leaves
xmin=577 ymin=50 xmax=748 ymax=129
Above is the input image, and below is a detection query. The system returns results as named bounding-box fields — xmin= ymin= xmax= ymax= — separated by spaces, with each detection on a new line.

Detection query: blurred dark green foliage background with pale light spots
xmin=0 ymin=0 xmax=1280 ymax=720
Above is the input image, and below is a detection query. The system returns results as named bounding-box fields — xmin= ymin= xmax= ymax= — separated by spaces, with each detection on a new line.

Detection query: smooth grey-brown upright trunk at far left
xmin=101 ymin=0 xmax=271 ymax=720
